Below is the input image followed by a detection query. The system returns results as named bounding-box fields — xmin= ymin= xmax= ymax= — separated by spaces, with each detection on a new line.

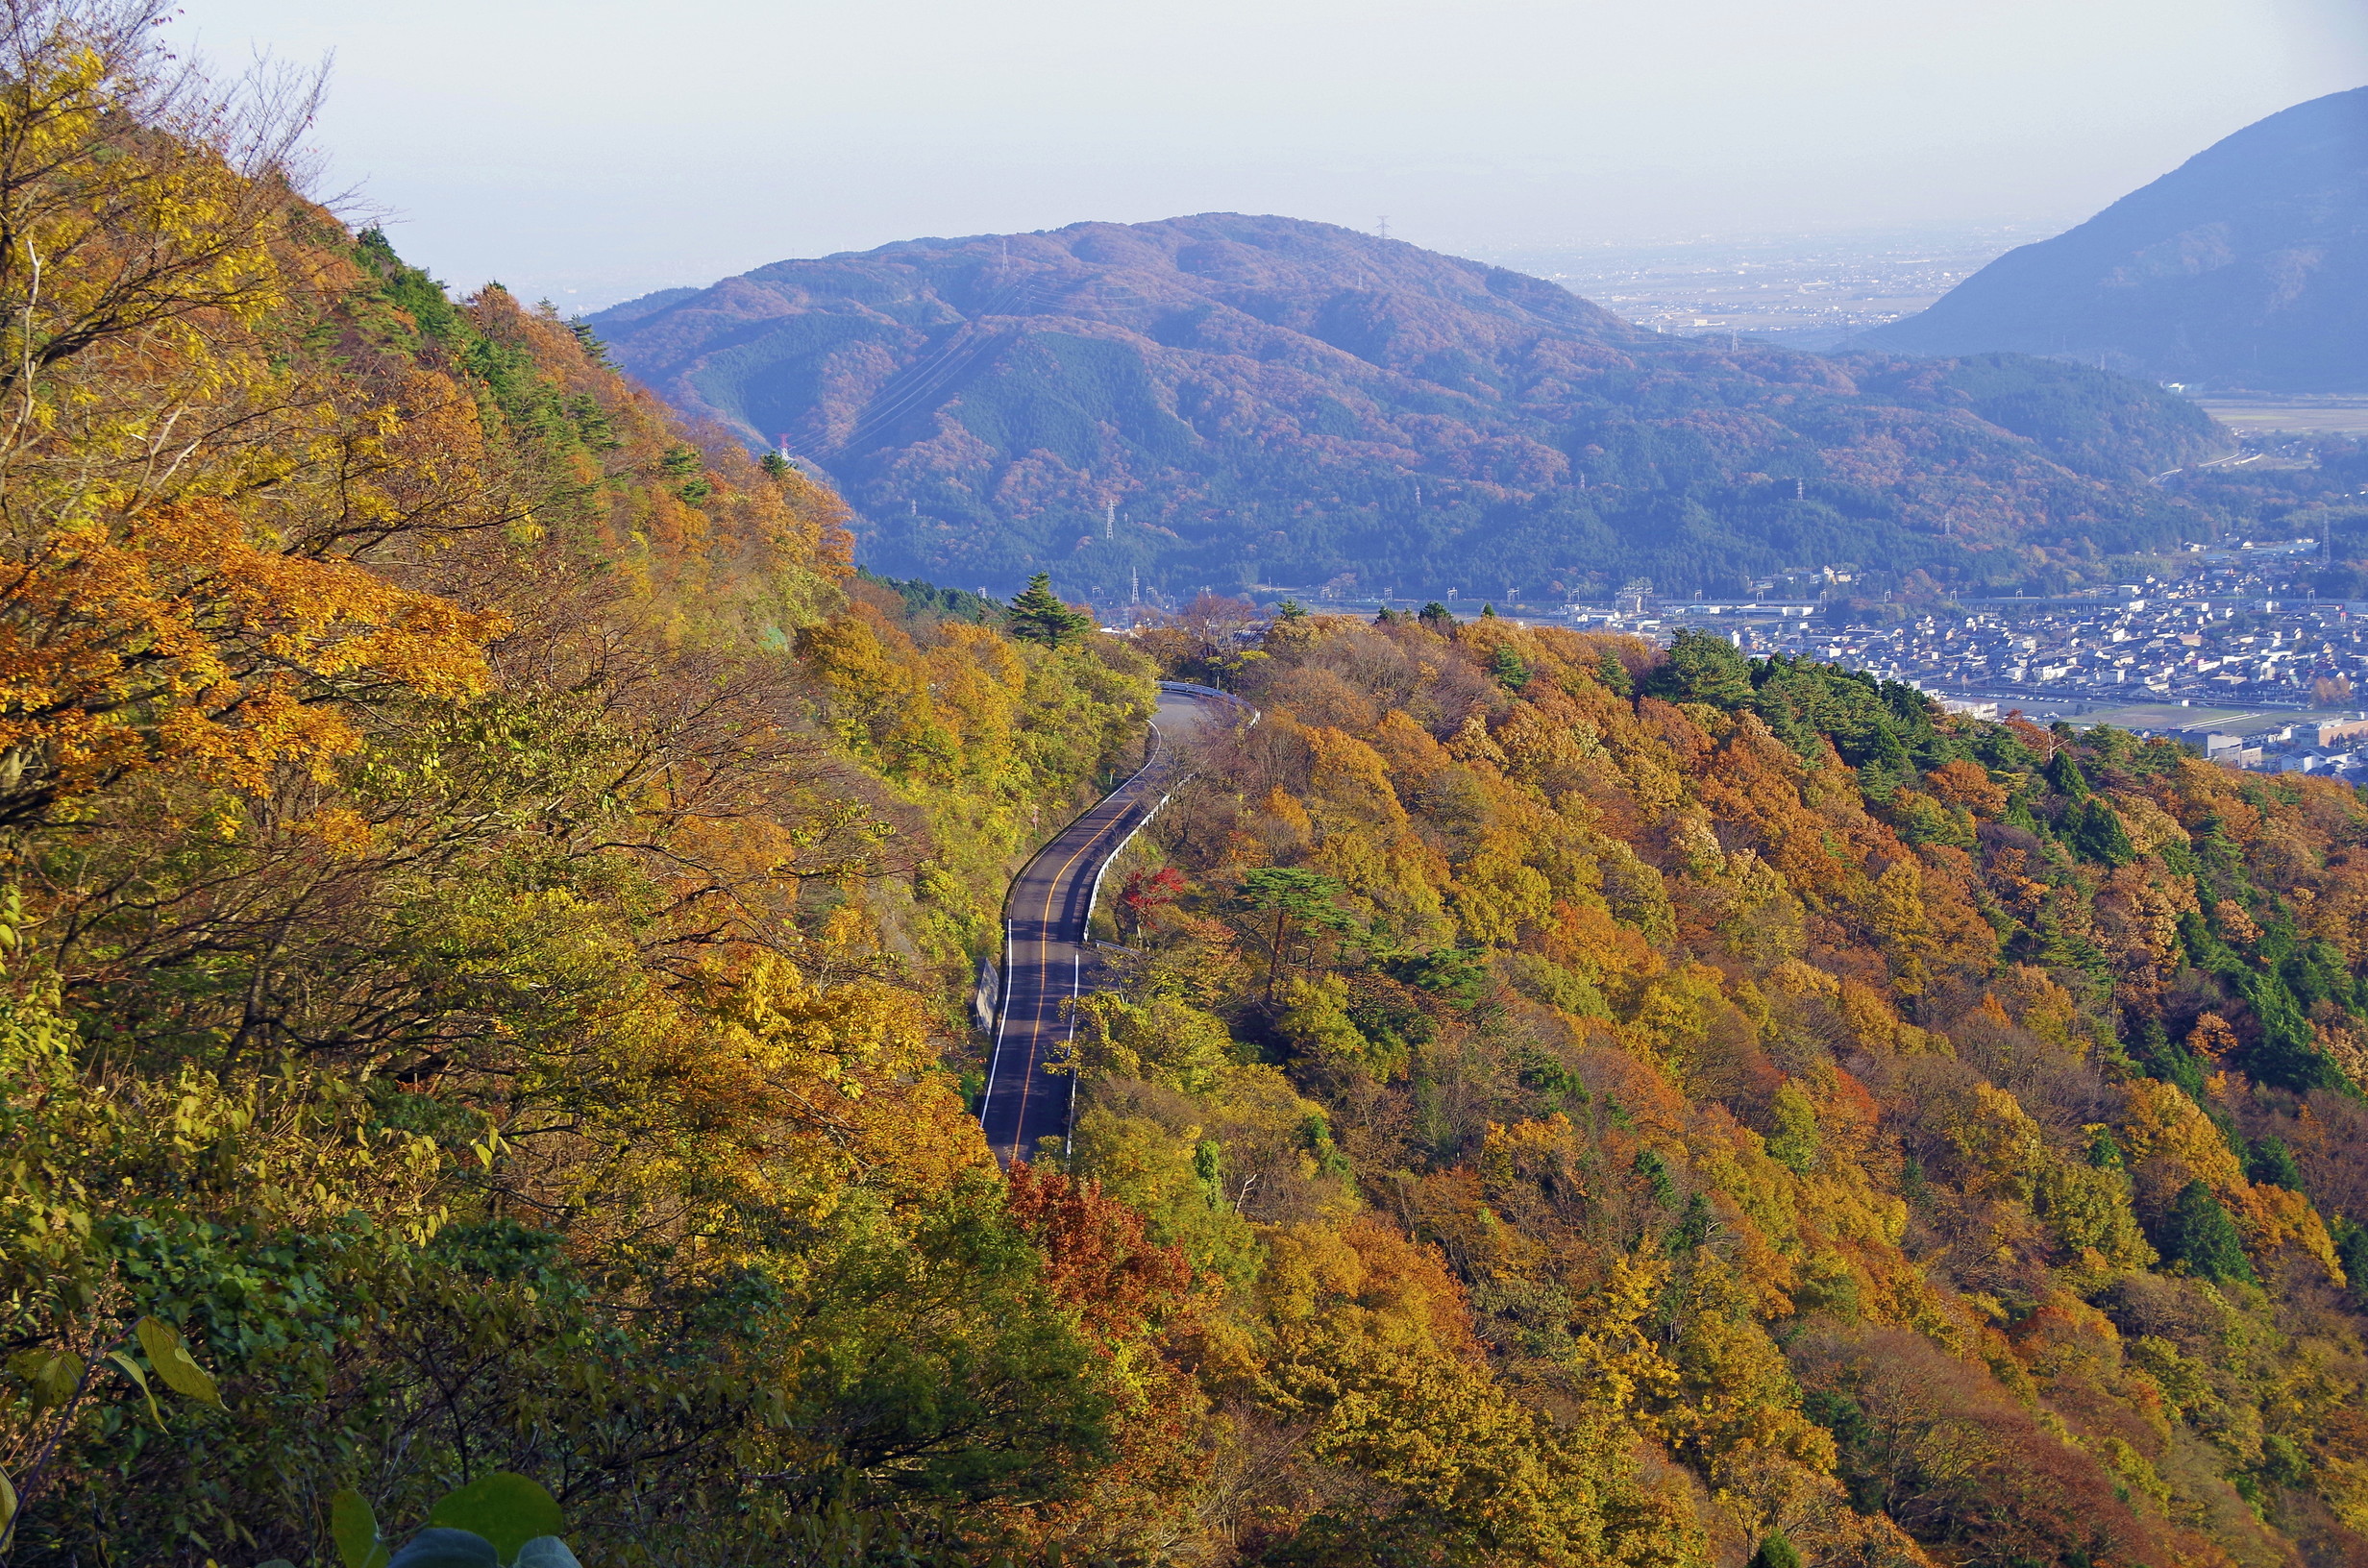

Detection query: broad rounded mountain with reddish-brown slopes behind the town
xmin=590 ymin=213 xmax=2221 ymax=601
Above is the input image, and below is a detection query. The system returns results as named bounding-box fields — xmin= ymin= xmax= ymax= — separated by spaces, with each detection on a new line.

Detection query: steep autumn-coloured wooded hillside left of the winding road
xmin=0 ymin=5 xmax=1148 ymax=1566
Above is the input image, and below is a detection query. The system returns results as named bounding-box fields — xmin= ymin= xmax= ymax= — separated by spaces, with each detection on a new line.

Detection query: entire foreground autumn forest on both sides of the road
xmin=0 ymin=0 xmax=2368 ymax=1568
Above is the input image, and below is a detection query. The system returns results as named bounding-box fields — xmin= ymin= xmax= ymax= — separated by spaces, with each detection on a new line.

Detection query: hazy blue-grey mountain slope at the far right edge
xmin=1862 ymin=87 xmax=2368 ymax=391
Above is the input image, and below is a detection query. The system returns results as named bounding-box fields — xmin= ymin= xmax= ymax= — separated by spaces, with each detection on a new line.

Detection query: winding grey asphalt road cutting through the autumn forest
xmin=978 ymin=689 xmax=1244 ymax=1165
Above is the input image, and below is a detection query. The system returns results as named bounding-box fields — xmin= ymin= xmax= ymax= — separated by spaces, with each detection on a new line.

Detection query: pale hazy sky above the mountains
xmin=178 ymin=0 xmax=2368 ymax=307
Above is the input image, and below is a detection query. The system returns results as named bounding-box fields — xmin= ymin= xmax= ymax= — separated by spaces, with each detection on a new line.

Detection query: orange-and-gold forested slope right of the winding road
xmin=1075 ymin=616 xmax=2368 ymax=1568
